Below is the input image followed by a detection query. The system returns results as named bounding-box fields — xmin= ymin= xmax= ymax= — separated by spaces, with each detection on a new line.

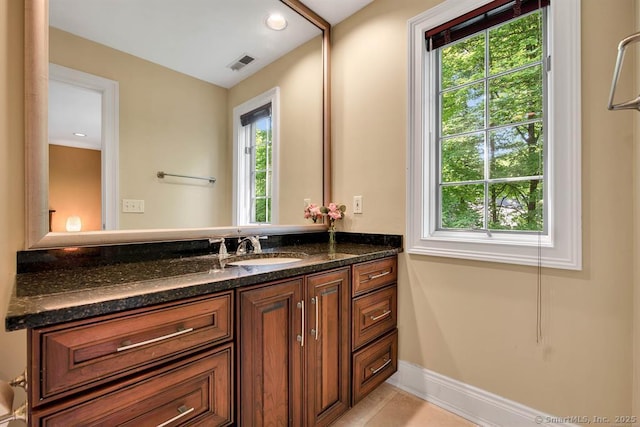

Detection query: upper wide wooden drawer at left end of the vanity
xmin=30 ymin=292 xmax=233 ymax=407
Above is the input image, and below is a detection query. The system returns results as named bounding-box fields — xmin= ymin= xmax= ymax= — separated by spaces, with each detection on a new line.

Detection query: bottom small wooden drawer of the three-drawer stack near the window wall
xmin=352 ymin=329 xmax=398 ymax=405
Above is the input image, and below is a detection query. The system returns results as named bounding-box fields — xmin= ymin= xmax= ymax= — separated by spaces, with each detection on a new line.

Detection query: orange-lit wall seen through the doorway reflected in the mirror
xmin=49 ymin=144 xmax=102 ymax=232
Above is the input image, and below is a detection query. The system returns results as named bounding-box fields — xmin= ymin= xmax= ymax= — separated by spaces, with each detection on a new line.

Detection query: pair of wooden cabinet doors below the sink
xmin=238 ymin=268 xmax=350 ymax=426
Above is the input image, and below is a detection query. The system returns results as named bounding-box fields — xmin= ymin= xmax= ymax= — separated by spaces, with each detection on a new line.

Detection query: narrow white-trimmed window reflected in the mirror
xmin=234 ymin=88 xmax=278 ymax=225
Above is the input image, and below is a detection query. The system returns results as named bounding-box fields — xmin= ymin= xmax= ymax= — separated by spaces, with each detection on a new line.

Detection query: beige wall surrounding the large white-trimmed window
xmin=333 ymin=0 xmax=640 ymax=422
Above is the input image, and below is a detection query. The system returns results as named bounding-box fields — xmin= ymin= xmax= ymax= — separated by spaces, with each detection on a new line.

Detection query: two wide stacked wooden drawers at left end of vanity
xmin=28 ymin=292 xmax=234 ymax=426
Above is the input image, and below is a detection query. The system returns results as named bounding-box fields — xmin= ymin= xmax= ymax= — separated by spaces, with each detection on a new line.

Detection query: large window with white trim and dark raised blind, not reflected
xmin=407 ymin=0 xmax=581 ymax=269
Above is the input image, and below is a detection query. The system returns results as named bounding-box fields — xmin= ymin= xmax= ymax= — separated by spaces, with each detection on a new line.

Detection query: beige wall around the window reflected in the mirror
xmin=229 ymin=37 xmax=322 ymax=224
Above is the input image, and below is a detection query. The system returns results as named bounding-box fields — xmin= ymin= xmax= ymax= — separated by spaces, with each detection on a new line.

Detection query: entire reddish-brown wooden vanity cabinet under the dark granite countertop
xmin=28 ymin=256 xmax=398 ymax=427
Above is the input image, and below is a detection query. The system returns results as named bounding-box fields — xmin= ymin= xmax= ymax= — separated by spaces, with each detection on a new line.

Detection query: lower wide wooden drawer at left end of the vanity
xmin=30 ymin=344 xmax=233 ymax=427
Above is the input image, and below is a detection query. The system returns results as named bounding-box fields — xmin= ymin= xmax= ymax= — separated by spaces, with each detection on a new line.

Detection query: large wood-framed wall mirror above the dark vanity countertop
xmin=25 ymin=0 xmax=330 ymax=248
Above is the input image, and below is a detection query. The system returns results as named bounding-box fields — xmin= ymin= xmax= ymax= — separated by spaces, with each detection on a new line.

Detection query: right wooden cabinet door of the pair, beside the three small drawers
xmin=305 ymin=268 xmax=351 ymax=426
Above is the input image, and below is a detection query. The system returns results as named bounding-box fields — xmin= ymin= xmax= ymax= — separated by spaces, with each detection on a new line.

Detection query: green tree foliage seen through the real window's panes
xmin=438 ymin=11 xmax=546 ymax=231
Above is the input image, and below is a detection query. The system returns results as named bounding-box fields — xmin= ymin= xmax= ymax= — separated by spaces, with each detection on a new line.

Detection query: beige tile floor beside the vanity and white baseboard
xmin=332 ymin=383 xmax=475 ymax=427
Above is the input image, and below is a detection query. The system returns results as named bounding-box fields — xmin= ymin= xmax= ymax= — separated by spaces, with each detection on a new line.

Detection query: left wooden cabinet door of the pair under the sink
xmin=238 ymin=279 xmax=307 ymax=426
